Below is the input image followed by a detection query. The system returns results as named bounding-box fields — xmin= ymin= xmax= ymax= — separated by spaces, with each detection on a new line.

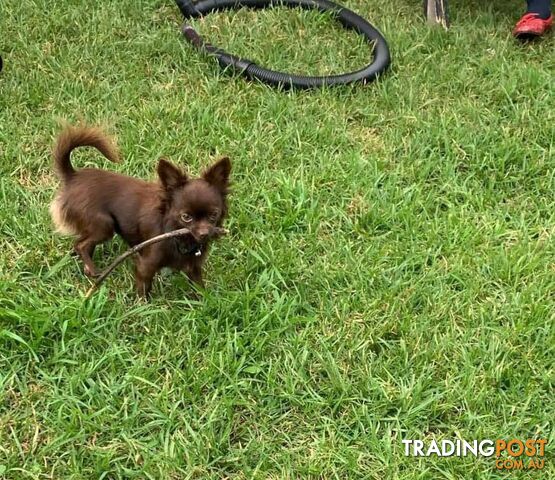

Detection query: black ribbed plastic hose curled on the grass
xmin=176 ymin=0 xmax=390 ymax=88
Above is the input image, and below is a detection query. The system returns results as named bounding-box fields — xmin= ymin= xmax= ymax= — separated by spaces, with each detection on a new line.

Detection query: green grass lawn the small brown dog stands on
xmin=0 ymin=0 xmax=555 ymax=480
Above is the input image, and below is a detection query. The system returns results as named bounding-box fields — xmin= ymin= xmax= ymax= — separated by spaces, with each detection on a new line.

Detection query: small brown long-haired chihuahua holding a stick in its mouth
xmin=50 ymin=126 xmax=231 ymax=296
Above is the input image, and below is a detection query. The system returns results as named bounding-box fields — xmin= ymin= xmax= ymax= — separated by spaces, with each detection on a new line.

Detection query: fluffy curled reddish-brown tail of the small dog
xmin=53 ymin=126 xmax=119 ymax=182
